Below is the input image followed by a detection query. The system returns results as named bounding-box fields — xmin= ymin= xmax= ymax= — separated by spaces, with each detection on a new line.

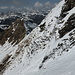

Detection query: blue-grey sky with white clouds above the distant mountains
xmin=0 ymin=0 xmax=60 ymax=12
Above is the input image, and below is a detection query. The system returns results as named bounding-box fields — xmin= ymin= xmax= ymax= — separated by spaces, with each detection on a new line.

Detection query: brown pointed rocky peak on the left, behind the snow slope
xmin=0 ymin=19 xmax=26 ymax=45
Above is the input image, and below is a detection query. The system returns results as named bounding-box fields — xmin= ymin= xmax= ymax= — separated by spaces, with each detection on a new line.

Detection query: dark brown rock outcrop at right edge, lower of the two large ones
xmin=59 ymin=14 xmax=75 ymax=38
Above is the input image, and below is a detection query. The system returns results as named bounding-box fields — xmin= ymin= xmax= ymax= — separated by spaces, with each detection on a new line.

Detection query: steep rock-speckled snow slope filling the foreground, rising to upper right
xmin=1 ymin=0 xmax=75 ymax=75
